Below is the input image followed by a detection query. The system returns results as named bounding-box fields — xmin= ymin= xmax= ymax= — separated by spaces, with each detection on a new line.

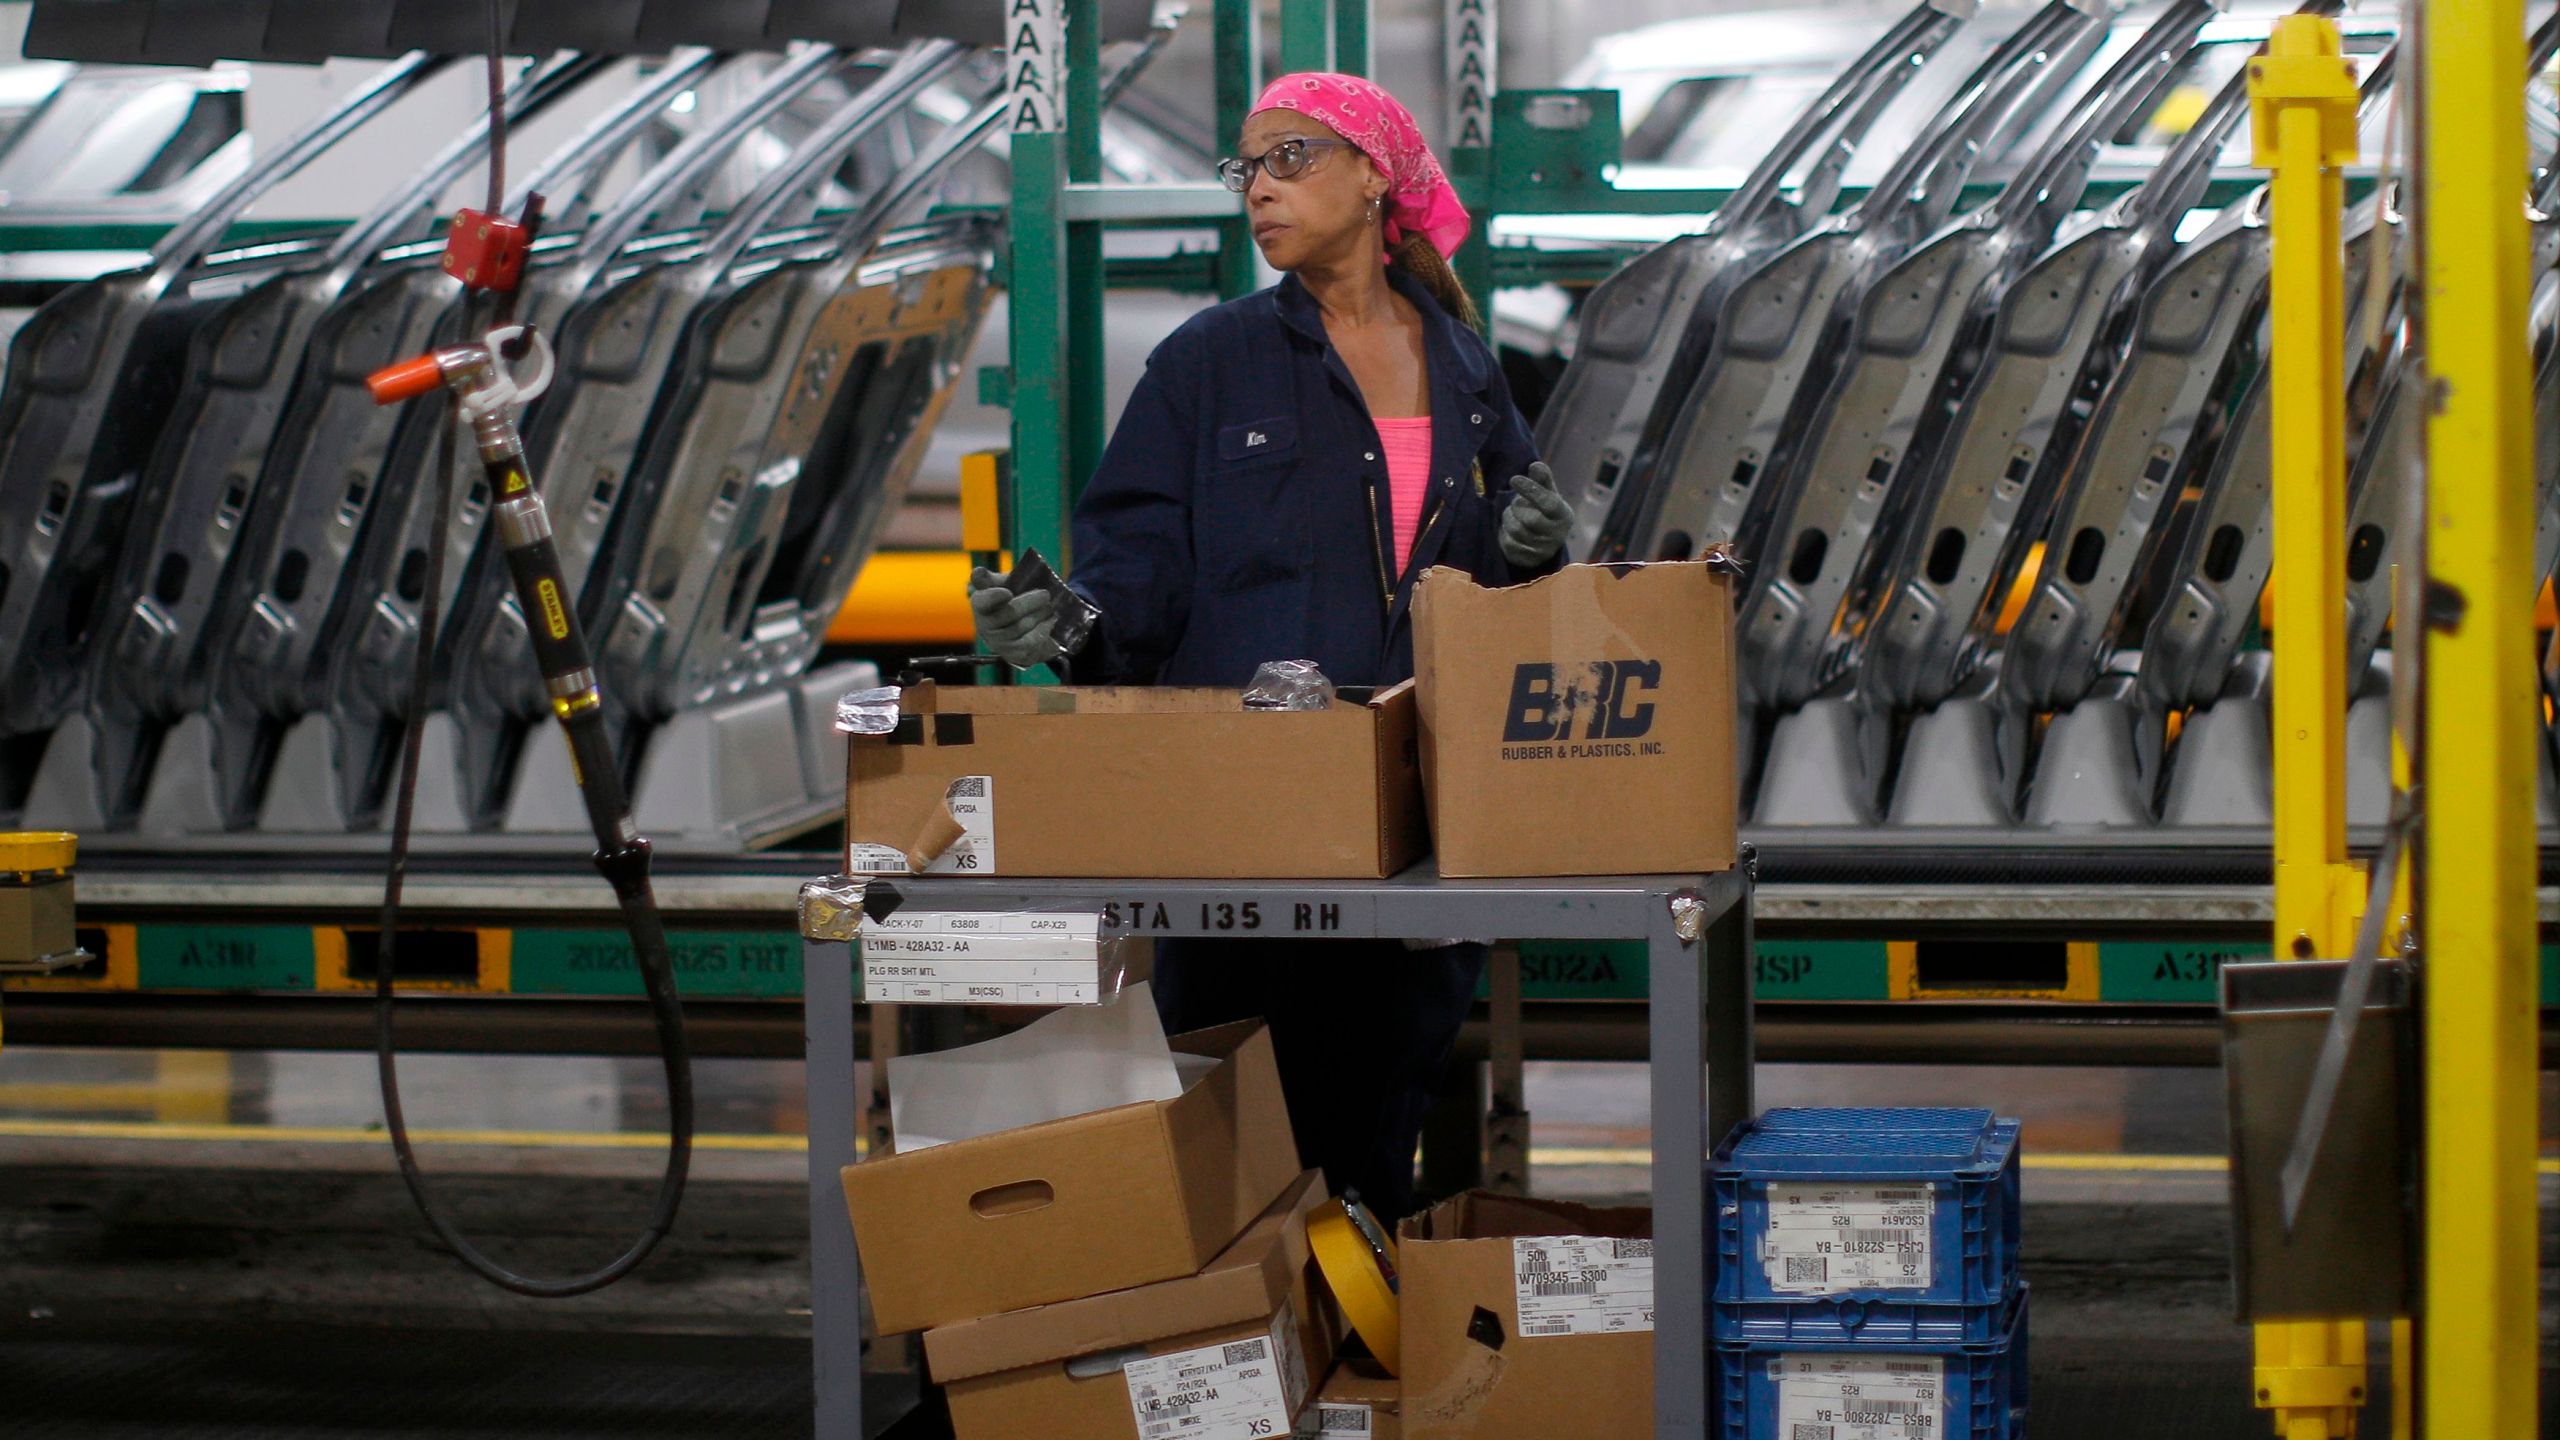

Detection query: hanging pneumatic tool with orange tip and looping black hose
xmin=366 ymin=0 xmax=694 ymax=1299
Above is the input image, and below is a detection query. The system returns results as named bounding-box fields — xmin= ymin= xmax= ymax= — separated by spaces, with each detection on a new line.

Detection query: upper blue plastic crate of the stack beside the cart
xmin=1713 ymin=1109 xmax=2020 ymax=1343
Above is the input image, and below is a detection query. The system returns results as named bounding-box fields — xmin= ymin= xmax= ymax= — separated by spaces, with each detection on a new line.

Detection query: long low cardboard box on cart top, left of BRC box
xmin=845 ymin=682 xmax=1426 ymax=879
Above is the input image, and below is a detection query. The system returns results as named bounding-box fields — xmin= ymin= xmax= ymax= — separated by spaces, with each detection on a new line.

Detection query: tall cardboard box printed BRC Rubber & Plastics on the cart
xmin=1413 ymin=561 xmax=1738 ymax=876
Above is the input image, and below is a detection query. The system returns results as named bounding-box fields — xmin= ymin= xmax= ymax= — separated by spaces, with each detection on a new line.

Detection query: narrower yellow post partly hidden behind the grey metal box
xmin=2250 ymin=15 xmax=2365 ymax=1440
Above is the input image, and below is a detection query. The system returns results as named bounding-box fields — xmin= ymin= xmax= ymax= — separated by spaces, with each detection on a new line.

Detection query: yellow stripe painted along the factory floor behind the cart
xmin=0 ymin=1120 xmax=2560 ymax=1176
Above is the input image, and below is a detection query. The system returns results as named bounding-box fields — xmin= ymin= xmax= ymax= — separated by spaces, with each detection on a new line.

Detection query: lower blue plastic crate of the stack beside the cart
xmin=1715 ymin=1289 xmax=2028 ymax=1440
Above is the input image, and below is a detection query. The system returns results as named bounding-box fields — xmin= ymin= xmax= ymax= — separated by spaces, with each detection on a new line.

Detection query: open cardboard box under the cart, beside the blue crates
xmin=1395 ymin=1191 xmax=1654 ymax=1440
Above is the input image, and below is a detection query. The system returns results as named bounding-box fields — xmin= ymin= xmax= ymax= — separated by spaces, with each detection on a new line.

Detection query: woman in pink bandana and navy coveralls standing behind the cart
xmin=970 ymin=74 xmax=1572 ymax=1220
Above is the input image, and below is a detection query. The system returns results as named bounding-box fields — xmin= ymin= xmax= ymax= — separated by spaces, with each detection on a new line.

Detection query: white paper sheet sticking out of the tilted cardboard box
xmin=888 ymin=984 xmax=1187 ymax=1153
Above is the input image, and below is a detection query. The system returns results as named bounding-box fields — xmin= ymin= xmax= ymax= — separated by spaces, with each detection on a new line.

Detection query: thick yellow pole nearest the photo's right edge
xmin=2404 ymin=0 xmax=2540 ymax=1440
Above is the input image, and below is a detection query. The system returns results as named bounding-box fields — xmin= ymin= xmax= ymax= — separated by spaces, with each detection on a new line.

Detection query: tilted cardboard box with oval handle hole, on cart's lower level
xmin=845 ymin=1020 xmax=1298 ymax=1335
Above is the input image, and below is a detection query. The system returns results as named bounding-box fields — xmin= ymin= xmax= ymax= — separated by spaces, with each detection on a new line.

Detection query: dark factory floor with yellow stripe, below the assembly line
xmin=0 ymin=1048 xmax=2560 ymax=1440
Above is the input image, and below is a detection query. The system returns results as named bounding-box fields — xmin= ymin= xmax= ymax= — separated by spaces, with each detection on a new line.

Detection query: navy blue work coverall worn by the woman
xmin=1073 ymin=269 xmax=1556 ymax=1220
